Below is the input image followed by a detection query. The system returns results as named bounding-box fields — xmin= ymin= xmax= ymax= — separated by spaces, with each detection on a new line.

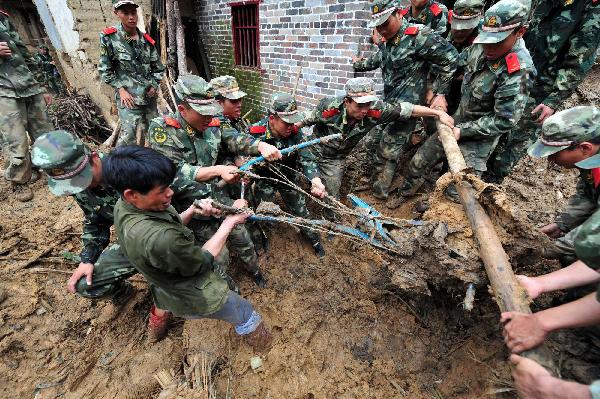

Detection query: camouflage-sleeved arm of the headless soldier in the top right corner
xmin=542 ymin=1 xmax=600 ymax=110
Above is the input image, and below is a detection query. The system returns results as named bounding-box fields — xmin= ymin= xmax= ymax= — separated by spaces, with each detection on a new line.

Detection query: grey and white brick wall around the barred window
xmin=195 ymin=0 xmax=379 ymax=118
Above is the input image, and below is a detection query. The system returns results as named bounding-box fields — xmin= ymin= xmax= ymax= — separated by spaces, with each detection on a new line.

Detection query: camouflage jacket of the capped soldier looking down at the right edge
xmin=556 ymin=168 xmax=600 ymax=233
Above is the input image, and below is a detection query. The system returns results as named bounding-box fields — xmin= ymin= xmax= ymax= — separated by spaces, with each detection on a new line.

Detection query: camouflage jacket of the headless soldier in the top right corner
xmin=525 ymin=0 xmax=600 ymax=109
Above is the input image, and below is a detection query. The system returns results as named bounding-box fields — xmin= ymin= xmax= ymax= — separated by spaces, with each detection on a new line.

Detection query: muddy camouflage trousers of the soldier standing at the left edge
xmin=0 ymin=94 xmax=54 ymax=184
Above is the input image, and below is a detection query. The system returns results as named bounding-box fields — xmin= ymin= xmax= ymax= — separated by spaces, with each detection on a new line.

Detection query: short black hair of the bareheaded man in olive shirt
xmin=102 ymin=145 xmax=177 ymax=195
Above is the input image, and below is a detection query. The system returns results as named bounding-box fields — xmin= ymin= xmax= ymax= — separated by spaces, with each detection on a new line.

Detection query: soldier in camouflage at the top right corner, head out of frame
xmin=490 ymin=0 xmax=600 ymax=178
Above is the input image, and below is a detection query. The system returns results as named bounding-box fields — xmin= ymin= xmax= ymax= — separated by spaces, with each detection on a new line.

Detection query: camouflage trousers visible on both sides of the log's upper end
xmin=401 ymin=134 xmax=499 ymax=194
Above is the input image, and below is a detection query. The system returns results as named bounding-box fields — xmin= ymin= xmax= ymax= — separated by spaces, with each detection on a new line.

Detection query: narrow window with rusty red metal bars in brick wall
xmin=231 ymin=1 xmax=260 ymax=68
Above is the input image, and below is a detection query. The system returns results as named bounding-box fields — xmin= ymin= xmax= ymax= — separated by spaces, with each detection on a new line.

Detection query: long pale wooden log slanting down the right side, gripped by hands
xmin=436 ymin=121 xmax=557 ymax=374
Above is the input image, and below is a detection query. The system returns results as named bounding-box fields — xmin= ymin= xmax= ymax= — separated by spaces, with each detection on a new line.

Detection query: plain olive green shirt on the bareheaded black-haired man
xmin=115 ymin=199 xmax=229 ymax=316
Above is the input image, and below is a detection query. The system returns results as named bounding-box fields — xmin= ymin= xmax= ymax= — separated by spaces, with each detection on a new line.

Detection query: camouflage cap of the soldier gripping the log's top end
xmin=473 ymin=0 xmax=529 ymax=44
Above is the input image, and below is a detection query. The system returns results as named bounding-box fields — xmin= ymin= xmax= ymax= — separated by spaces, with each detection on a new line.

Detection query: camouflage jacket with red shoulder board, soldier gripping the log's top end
xmin=454 ymin=40 xmax=535 ymax=140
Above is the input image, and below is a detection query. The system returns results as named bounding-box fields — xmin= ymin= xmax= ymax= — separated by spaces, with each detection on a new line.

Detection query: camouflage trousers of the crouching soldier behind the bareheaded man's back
xmin=75 ymin=244 xmax=137 ymax=299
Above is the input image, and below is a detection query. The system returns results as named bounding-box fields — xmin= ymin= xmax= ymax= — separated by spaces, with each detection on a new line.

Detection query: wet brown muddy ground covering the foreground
xmin=0 ymin=69 xmax=598 ymax=399
